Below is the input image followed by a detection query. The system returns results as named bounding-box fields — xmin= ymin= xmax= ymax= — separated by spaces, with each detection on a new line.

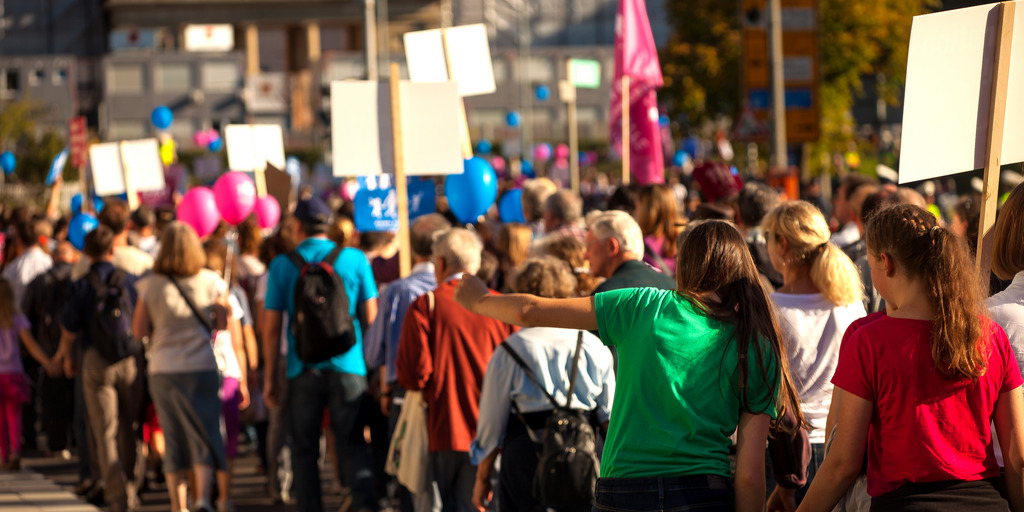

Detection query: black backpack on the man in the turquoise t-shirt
xmin=288 ymin=246 xmax=355 ymax=365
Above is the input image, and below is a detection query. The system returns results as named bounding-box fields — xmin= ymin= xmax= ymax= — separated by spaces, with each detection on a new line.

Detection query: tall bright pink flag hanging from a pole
xmin=611 ymin=0 xmax=665 ymax=184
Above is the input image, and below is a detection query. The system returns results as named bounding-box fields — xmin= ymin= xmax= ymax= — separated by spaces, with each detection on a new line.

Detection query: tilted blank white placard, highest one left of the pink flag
xmin=403 ymin=24 xmax=497 ymax=96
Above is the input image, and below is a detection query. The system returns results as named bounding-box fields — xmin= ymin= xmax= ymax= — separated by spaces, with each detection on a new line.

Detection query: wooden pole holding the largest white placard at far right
xmin=977 ymin=2 xmax=1016 ymax=296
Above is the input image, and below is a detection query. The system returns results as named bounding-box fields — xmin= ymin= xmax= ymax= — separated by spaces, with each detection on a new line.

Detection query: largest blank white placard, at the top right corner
xmin=899 ymin=4 xmax=1024 ymax=183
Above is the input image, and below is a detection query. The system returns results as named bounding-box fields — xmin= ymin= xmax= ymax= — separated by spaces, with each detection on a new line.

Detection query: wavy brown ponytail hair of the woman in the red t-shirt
xmin=866 ymin=205 xmax=987 ymax=379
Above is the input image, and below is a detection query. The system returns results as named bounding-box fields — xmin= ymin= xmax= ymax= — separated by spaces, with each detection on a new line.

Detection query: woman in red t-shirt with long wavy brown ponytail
xmin=798 ymin=205 xmax=1024 ymax=512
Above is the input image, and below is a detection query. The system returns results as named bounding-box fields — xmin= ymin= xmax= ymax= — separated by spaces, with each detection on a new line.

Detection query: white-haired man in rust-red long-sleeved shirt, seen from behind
xmin=396 ymin=228 xmax=517 ymax=511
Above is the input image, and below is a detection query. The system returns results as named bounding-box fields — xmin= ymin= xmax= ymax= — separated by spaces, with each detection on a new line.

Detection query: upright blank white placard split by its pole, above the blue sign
xmin=331 ymin=81 xmax=463 ymax=176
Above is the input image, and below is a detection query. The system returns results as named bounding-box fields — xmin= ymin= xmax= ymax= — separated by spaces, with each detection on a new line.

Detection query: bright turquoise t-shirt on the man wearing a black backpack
xmin=264 ymin=237 xmax=377 ymax=379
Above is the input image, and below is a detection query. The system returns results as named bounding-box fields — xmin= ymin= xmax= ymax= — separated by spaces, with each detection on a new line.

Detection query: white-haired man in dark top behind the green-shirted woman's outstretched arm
xmin=584 ymin=210 xmax=676 ymax=294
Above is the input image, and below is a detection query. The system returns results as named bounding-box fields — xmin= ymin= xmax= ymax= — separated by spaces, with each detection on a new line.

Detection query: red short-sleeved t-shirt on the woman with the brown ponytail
xmin=833 ymin=312 xmax=1024 ymax=496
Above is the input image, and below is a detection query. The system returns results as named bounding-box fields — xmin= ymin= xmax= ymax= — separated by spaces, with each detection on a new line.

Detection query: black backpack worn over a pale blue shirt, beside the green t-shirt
xmin=502 ymin=331 xmax=601 ymax=511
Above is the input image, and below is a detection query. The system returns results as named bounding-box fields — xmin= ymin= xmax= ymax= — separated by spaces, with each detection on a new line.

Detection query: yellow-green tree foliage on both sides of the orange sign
xmin=659 ymin=0 xmax=940 ymax=148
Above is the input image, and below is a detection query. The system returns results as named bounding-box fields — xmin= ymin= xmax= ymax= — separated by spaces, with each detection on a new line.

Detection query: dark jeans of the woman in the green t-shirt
xmin=594 ymin=475 xmax=735 ymax=512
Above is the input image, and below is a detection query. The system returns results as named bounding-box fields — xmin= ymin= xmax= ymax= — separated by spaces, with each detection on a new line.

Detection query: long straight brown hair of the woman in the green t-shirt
xmin=676 ymin=220 xmax=805 ymax=427
